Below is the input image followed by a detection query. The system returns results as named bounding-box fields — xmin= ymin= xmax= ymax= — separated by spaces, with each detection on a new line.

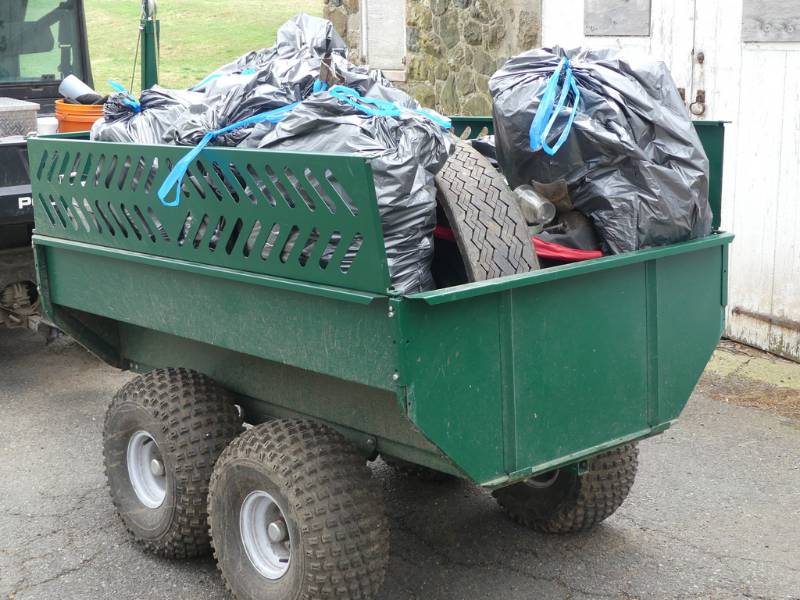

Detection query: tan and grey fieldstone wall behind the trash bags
xmin=324 ymin=0 xmax=541 ymax=115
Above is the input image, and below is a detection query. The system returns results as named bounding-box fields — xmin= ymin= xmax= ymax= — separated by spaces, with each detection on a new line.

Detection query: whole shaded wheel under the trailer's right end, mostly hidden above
xmin=493 ymin=444 xmax=639 ymax=533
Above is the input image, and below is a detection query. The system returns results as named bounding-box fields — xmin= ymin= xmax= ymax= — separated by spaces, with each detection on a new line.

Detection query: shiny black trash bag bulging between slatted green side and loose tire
xmin=242 ymin=92 xmax=454 ymax=294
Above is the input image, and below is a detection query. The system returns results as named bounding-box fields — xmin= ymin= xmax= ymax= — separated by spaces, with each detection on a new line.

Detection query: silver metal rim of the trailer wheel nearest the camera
xmin=239 ymin=490 xmax=292 ymax=579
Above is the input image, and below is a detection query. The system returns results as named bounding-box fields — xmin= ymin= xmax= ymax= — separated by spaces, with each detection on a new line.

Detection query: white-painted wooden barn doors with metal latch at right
xmin=542 ymin=0 xmax=800 ymax=360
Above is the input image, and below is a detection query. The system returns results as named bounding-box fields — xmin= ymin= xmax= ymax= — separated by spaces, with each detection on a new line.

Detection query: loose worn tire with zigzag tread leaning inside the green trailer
xmin=436 ymin=141 xmax=539 ymax=281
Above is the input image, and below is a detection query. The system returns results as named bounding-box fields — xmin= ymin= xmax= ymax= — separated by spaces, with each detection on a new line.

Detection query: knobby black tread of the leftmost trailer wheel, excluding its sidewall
xmin=103 ymin=368 xmax=242 ymax=558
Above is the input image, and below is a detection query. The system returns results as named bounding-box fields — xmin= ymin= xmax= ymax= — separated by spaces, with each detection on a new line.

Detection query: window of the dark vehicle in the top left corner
xmin=0 ymin=0 xmax=83 ymax=83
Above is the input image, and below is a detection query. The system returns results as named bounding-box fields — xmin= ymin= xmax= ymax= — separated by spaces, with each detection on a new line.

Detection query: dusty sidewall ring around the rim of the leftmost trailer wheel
xmin=104 ymin=402 xmax=176 ymax=541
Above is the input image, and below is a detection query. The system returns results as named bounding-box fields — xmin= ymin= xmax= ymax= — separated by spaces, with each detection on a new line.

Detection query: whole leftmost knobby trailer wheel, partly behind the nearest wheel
xmin=103 ymin=369 xmax=242 ymax=558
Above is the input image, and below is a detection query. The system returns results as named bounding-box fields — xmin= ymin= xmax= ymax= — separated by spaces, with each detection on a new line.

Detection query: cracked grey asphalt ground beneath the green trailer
xmin=0 ymin=331 xmax=800 ymax=600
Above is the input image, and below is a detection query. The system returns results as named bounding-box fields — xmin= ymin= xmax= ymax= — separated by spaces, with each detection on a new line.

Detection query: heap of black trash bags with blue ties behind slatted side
xmin=91 ymin=15 xmax=455 ymax=294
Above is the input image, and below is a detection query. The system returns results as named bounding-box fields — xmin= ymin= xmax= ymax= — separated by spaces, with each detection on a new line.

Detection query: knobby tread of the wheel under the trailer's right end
xmin=494 ymin=443 xmax=639 ymax=533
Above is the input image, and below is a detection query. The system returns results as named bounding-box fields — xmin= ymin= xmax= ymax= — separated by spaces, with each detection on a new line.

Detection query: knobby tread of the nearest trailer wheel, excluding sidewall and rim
xmin=208 ymin=419 xmax=389 ymax=600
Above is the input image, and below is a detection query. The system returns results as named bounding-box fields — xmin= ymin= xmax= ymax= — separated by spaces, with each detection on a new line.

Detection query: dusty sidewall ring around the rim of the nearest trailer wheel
xmin=210 ymin=459 xmax=305 ymax=600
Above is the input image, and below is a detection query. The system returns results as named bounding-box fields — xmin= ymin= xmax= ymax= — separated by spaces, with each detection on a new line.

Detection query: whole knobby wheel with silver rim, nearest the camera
xmin=208 ymin=419 xmax=389 ymax=600
